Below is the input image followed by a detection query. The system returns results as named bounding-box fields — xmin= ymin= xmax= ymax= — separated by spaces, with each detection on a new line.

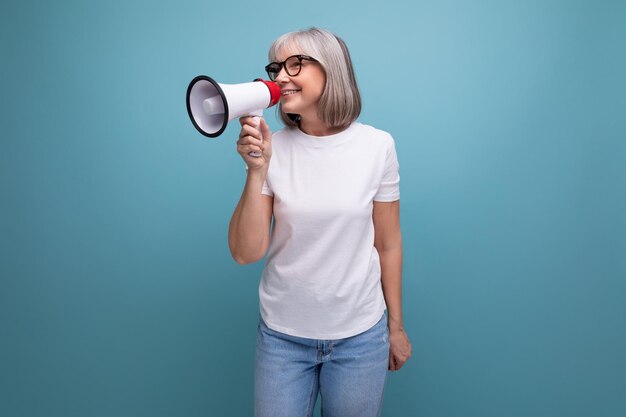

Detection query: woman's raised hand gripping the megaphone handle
xmin=237 ymin=116 xmax=272 ymax=172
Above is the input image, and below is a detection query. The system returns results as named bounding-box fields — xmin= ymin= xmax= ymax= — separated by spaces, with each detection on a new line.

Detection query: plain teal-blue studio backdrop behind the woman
xmin=0 ymin=0 xmax=626 ymax=417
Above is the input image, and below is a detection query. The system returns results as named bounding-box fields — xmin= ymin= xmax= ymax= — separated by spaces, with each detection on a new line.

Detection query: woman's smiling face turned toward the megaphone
xmin=276 ymin=49 xmax=326 ymax=120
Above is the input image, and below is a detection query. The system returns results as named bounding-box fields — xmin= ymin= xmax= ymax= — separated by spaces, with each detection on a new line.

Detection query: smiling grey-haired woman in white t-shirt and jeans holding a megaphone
xmin=229 ymin=28 xmax=411 ymax=417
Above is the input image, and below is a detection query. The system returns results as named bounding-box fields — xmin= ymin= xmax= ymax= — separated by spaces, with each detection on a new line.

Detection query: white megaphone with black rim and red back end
xmin=187 ymin=75 xmax=280 ymax=156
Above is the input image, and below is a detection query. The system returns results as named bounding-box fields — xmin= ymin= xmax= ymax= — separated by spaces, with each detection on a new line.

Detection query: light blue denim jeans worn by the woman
xmin=254 ymin=314 xmax=389 ymax=417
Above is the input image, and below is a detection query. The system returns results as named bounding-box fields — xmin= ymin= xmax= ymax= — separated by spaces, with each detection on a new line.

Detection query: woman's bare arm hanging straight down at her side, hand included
xmin=372 ymin=200 xmax=411 ymax=371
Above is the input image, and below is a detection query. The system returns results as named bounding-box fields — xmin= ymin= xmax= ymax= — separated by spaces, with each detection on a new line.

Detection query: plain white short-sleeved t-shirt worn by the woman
xmin=259 ymin=122 xmax=400 ymax=340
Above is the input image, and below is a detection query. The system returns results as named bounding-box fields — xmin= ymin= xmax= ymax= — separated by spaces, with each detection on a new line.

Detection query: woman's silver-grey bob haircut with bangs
xmin=269 ymin=27 xmax=361 ymax=127
